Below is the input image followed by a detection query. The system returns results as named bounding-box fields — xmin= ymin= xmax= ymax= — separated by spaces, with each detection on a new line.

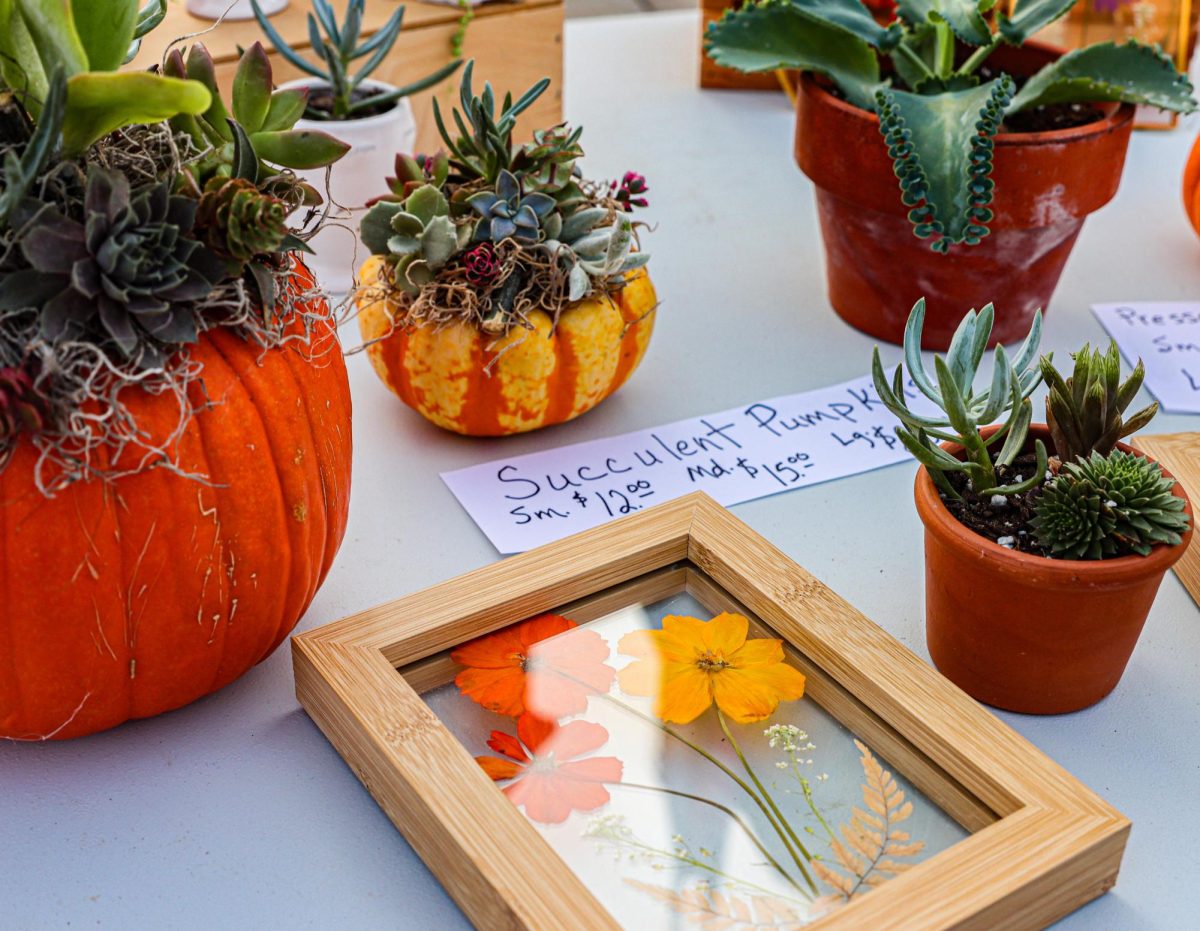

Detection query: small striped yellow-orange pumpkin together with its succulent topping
xmin=358 ymin=62 xmax=656 ymax=436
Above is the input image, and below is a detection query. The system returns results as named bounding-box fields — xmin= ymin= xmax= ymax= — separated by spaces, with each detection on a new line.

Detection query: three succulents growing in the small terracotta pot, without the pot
xmin=871 ymin=301 xmax=1190 ymax=559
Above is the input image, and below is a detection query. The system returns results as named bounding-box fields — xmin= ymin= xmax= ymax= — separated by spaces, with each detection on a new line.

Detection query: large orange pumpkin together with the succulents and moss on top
xmin=0 ymin=0 xmax=350 ymax=739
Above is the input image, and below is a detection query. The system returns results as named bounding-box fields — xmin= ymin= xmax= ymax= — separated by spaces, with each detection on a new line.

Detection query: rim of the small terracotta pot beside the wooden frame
xmin=913 ymin=424 xmax=1195 ymax=585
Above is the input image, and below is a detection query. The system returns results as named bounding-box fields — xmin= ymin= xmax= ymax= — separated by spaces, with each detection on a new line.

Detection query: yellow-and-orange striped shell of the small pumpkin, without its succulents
xmin=359 ymin=257 xmax=656 ymax=437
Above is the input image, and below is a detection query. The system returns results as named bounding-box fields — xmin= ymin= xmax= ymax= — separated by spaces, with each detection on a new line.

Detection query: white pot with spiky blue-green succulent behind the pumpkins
xmin=251 ymin=0 xmax=462 ymax=292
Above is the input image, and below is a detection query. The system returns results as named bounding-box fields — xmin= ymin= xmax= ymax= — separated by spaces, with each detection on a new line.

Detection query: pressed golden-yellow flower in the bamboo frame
xmin=617 ymin=613 xmax=804 ymax=725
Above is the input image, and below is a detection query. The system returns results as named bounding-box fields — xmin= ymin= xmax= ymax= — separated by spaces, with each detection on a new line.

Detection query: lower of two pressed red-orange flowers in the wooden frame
xmin=475 ymin=714 xmax=623 ymax=824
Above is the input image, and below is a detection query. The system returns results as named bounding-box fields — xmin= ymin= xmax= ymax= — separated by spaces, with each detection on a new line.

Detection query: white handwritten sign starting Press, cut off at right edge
xmin=1092 ymin=302 xmax=1200 ymax=414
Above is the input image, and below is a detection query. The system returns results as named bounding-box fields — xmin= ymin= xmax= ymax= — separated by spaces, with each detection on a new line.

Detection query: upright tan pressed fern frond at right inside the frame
xmin=812 ymin=740 xmax=925 ymax=900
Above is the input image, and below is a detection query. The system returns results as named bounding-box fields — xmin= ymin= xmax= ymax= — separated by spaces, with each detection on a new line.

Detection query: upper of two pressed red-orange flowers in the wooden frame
xmin=450 ymin=614 xmax=616 ymax=720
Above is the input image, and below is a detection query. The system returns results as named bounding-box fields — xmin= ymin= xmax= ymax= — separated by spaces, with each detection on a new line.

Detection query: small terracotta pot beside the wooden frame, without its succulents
xmin=916 ymin=425 xmax=1192 ymax=714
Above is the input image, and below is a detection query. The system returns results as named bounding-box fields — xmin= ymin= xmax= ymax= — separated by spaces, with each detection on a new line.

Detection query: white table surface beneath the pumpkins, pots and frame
xmin=0 ymin=12 xmax=1200 ymax=931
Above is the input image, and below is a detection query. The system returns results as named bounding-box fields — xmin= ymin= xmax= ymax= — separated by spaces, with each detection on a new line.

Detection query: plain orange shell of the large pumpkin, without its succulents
xmin=0 ymin=263 xmax=350 ymax=739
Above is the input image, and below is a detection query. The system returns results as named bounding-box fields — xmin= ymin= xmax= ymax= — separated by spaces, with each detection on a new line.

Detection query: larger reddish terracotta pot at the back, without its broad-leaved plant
xmin=796 ymin=43 xmax=1134 ymax=349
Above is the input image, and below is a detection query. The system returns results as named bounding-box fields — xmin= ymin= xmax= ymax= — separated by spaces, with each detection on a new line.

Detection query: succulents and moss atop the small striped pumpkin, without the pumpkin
xmin=360 ymin=62 xmax=649 ymax=331
